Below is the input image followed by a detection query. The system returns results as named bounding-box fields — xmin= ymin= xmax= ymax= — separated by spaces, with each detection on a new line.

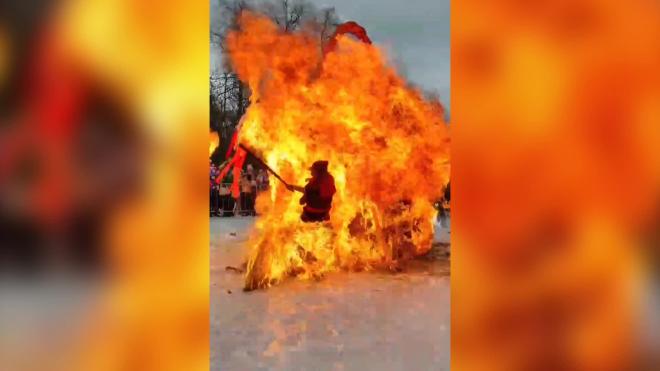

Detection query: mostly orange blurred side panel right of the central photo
xmin=451 ymin=0 xmax=660 ymax=371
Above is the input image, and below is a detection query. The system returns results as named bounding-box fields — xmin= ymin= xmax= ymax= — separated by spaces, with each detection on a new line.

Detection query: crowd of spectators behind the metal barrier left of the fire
xmin=209 ymin=162 xmax=269 ymax=216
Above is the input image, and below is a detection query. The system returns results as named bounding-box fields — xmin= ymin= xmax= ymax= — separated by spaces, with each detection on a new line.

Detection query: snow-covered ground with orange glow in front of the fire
xmin=210 ymin=217 xmax=450 ymax=371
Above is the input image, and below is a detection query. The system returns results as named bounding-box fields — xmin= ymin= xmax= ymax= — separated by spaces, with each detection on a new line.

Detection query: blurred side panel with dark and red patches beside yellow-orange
xmin=0 ymin=0 xmax=209 ymax=370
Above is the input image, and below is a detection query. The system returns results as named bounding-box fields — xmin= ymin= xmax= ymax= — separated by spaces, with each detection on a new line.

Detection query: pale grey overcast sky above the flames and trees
xmin=211 ymin=0 xmax=450 ymax=107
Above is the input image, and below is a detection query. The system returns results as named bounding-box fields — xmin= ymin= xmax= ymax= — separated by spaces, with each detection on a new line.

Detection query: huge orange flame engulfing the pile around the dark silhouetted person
xmin=228 ymin=13 xmax=449 ymax=289
